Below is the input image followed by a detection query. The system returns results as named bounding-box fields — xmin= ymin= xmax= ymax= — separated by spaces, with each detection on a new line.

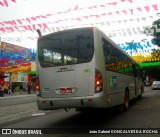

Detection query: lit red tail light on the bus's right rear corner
xmin=95 ymin=70 xmax=103 ymax=93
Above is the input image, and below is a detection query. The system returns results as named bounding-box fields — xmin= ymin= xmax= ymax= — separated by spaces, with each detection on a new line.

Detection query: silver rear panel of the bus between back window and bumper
xmin=39 ymin=62 xmax=95 ymax=98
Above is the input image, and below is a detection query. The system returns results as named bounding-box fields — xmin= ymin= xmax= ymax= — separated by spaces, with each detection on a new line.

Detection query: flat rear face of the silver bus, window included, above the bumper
xmin=38 ymin=29 xmax=95 ymax=98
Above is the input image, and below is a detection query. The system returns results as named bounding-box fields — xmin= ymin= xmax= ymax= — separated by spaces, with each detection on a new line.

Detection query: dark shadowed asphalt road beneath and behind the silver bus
xmin=0 ymin=87 xmax=160 ymax=137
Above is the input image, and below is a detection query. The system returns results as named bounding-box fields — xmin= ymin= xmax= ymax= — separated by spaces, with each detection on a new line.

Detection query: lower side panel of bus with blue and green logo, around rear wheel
xmin=106 ymin=70 xmax=135 ymax=106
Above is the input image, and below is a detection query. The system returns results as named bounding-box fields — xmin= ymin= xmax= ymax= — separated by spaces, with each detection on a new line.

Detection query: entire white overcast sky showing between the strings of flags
xmin=0 ymin=0 xmax=160 ymax=48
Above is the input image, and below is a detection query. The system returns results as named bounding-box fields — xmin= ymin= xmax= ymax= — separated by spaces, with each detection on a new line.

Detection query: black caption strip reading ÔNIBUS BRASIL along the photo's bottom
xmin=0 ymin=128 xmax=160 ymax=135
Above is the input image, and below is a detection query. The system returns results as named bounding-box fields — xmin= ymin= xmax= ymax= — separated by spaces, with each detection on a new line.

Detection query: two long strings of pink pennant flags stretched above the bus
xmin=0 ymin=3 xmax=159 ymax=33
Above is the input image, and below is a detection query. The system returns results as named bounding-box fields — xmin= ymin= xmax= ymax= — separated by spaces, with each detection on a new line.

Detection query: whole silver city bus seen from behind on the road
xmin=36 ymin=27 xmax=144 ymax=110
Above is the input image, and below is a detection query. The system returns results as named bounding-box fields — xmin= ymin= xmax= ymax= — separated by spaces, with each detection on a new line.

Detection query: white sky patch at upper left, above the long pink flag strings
xmin=0 ymin=0 xmax=105 ymax=21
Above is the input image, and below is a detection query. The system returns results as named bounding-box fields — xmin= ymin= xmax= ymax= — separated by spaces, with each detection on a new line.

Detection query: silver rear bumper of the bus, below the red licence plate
xmin=37 ymin=96 xmax=107 ymax=110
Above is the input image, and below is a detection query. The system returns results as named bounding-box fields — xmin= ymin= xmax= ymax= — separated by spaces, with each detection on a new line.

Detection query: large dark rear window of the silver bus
xmin=38 ymin=29 xmax=94 ymax=67
